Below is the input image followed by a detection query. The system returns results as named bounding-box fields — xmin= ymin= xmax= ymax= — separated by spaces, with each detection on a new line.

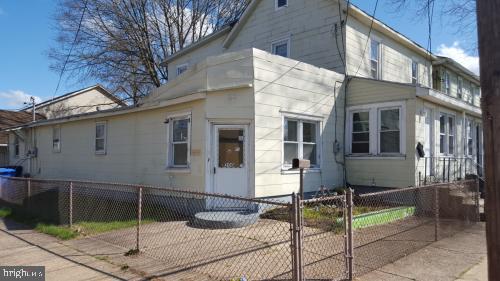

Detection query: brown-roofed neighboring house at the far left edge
xmin=0 ymin=110 xmax=45 ymax=167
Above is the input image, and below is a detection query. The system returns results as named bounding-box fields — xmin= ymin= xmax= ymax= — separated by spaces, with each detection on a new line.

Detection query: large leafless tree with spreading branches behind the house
xmin=48 ymin=0 xmax=247 ymax=103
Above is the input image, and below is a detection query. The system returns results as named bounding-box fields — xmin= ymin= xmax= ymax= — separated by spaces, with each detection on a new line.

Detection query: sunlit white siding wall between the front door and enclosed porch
xmin=254 ymin=51 xmax=344 ymax=196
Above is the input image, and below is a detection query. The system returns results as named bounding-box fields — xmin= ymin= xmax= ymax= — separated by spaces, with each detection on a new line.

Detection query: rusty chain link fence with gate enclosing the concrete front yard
xmin=0 ymin=177 xmax=479 ymax=280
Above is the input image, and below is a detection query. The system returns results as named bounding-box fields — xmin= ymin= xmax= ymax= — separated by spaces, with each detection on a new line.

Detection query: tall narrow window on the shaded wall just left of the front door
xmin=168 ymin=116 xmax=191 ymax=168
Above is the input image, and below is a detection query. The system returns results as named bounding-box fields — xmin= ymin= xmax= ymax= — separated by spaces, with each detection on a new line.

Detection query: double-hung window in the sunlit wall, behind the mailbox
xmin=283 ymin=118 xmax=319 ymax=168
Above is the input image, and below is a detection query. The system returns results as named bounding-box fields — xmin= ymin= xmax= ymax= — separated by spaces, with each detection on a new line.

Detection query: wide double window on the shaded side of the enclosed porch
xmin=346 ymin=102 xmax=406 ymax=157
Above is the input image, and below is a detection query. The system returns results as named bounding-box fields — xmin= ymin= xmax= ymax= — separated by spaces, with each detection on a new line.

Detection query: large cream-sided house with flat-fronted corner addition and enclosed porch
xmin=1 ymin=0 xmax=482 ymax=197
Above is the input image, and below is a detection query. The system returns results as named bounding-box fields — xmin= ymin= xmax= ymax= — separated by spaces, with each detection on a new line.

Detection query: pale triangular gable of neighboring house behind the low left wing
xmin=22 ymin=84 xmax=126 ymax=119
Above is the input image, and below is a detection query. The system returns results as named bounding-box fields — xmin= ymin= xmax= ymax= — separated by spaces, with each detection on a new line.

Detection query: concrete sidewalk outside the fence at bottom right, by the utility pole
xmin=356 ymin=223 xmax=488 ymax=281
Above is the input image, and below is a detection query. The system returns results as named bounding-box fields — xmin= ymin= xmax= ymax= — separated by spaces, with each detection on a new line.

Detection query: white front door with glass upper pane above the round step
xmin=211 ymin=125 xmax=248 ymax=198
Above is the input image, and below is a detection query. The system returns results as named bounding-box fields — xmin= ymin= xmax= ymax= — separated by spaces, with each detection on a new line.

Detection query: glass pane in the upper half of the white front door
xmin=218 ymin=129 xmax=245 ymax=169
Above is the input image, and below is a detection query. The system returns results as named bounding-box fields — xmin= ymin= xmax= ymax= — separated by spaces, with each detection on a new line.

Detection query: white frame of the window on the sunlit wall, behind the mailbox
xmin=281 ymin=114 xmax=323 ymax=170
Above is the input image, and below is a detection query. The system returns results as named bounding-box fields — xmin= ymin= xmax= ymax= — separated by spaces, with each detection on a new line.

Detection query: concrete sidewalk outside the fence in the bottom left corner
xmin=0 ymin=220 xmax=141 ymax=281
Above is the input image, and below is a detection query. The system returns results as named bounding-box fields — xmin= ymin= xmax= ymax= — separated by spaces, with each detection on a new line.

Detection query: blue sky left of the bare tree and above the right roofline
xmin=0 ymin=0 xmax=479 ymax=110
